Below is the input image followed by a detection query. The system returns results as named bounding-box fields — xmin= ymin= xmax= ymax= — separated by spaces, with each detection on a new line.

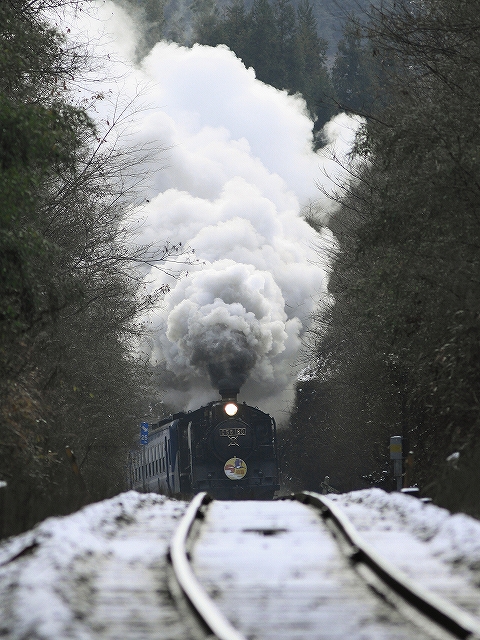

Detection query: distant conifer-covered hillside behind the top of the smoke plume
xmin=115 ymin=0 xmax=382 ymax=141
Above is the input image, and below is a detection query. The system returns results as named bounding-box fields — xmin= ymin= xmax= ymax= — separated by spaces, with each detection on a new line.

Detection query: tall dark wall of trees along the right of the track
xmin=284 ymin=0 xmax=480 ymax=516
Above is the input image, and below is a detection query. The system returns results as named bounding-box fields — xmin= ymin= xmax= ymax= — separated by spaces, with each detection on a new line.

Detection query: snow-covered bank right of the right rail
xmin=328 ymin=489 xmax=480 ymax=616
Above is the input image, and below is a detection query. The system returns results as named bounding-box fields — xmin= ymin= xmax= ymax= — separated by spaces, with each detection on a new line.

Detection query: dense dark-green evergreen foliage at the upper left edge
xmin=0 ymin=3 xmax=93 ymax=375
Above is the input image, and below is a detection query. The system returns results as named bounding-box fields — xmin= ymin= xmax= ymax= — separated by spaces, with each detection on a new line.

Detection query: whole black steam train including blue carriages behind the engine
xmin=128 ymin=389 xmax=280 ymax=500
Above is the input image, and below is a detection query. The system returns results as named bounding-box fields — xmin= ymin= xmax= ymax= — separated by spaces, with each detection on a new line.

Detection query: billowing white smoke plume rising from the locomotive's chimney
xmin=67 ymin=2 xmax=356 ymax=417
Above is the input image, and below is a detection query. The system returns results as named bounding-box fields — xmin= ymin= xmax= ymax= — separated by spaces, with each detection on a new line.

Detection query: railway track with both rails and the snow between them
xmin=169 ymin=492 xmax=480 ymax=640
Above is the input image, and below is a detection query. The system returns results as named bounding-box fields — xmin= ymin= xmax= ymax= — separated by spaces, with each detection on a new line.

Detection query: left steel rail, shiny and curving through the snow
xmin=169 ymin=492 xmax=246 ymax=640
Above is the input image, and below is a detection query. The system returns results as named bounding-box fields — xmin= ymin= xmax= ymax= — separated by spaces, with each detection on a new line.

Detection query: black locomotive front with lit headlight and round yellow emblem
xmin=188 ymin=389 xmax=279 ymax=500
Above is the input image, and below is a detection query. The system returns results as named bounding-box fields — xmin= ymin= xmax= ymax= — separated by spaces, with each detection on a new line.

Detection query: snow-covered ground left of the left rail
xmin=0 ymin=491 xmax=185 ymax=640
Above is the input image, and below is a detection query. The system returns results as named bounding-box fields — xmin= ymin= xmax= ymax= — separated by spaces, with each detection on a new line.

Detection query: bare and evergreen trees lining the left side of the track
xmin=0 ymin=0 xmax=175 ymax=535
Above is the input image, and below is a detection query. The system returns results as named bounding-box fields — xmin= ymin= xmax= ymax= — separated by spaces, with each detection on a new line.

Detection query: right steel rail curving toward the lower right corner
xmin=290 ymin=491 xmax=480 ymax=640
